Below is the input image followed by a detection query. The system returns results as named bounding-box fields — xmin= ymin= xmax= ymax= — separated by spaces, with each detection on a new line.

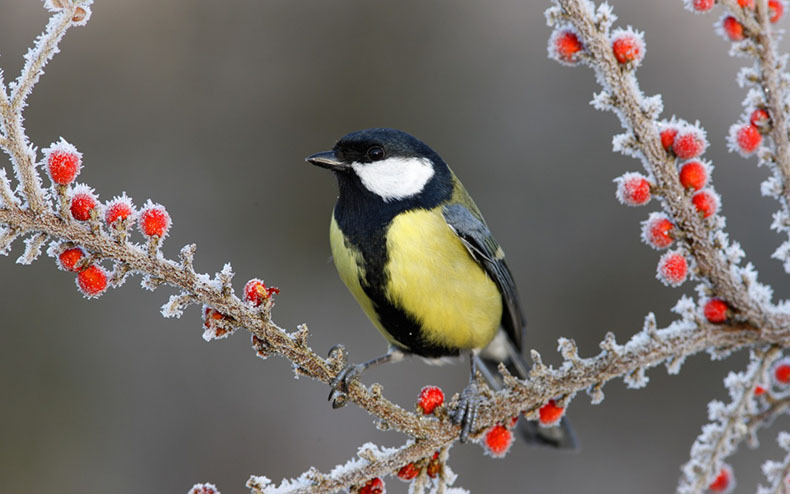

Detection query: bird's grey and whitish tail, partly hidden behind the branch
xmin=480 ymin=331 xmax=578 ymax=450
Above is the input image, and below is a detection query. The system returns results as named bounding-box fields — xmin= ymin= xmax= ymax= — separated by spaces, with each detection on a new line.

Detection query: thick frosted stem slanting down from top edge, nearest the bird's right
xmin=546 ymin=0 xmax=776 ymax=327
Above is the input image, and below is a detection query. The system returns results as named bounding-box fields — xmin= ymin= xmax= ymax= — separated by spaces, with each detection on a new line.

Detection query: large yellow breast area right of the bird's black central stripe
xmin=385 ymin=208 xmax=502 ymax=349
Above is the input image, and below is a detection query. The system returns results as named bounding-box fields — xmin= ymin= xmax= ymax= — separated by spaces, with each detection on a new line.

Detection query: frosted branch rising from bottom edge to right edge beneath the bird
xmin=249 ymin=310 xmax=790 ymax=494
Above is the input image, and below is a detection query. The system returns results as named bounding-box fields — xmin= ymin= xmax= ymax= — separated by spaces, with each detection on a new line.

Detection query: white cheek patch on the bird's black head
xmin=351 ymin=158 xmax=434 ymax=202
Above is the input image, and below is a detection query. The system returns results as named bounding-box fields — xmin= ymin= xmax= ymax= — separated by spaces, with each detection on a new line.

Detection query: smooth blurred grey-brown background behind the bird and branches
xmin=0 ymin=0 xmax=790 ymax=494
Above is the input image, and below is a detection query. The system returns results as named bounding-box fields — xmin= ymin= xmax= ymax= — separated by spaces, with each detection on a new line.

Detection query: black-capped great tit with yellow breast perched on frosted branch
xmin=305 ymin=128 xmax=576 ymax=449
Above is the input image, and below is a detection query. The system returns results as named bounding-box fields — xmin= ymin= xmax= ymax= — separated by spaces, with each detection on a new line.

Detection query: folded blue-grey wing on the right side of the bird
xmin=442 ymin=204 xmax=526 ymax=351
